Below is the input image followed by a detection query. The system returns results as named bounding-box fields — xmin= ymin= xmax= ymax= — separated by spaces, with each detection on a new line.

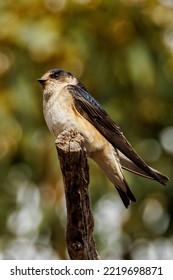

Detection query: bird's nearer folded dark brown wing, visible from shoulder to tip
xmin=68 ymin=85 xmax=168 ymax=185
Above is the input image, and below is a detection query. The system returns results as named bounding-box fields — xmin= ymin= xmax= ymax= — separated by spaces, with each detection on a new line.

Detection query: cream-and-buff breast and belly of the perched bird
xmin=43 ymin=86 xmax=107 ymax=155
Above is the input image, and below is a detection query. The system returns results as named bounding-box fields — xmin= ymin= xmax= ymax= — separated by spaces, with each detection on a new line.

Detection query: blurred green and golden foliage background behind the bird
xmin=0 ymin=0 xmax=173 ymax=259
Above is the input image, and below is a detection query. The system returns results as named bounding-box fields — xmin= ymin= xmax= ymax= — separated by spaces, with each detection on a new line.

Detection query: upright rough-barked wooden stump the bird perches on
xmin=55 ymin=129 xmax=99 ymax=260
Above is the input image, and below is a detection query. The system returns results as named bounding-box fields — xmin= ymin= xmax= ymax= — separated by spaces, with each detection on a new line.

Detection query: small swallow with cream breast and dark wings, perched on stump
xmin=37 ymin=69 xmax=169 ymax=208
